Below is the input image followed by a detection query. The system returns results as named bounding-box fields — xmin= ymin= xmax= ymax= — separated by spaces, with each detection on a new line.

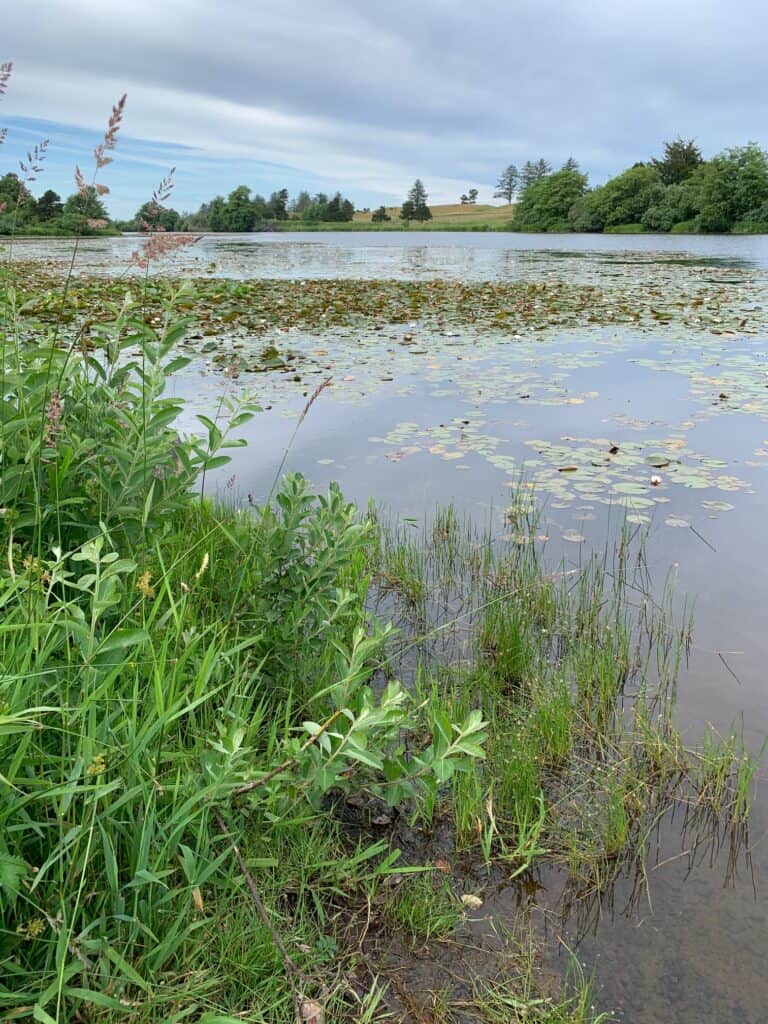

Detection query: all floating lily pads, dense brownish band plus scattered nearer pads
xmin=13 ymin=253 xmax=768 ymax=540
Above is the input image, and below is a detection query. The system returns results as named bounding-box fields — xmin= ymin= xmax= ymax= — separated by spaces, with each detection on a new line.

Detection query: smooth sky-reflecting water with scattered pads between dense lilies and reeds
xmin=177 ymin=332 xmax=768 ymax=739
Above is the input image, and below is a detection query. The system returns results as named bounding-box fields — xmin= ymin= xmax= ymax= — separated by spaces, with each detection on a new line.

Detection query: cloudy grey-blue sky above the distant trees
xmin=0 ymin=0 xmax=768 ymax=216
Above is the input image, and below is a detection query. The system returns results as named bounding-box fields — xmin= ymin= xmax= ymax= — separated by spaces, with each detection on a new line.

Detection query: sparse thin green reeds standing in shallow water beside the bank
xmin=372 ymin=507 xmax=757 ymax=886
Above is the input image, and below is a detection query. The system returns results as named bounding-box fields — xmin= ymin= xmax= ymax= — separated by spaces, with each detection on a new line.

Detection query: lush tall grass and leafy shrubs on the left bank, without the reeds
xmin=0 ymin=276 xmax=484 ymax=1021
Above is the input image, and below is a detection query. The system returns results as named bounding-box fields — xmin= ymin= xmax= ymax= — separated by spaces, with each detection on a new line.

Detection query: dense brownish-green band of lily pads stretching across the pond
xmin=13 ymin=261 xmax=768 ymax=362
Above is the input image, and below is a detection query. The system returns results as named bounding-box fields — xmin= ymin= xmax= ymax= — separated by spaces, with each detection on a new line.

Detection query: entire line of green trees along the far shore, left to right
xmin=0 ymin=138 xmax=768 ymax=234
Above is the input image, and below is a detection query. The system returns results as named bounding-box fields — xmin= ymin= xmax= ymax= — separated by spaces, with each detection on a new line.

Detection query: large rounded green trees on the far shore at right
xmin=496 ymin=138 xmax=768 ymax=233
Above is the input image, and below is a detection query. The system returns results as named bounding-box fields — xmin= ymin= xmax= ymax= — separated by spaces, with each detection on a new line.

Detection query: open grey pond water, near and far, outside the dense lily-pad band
xmin=34 ymin=231 xmax=768 ymax=1024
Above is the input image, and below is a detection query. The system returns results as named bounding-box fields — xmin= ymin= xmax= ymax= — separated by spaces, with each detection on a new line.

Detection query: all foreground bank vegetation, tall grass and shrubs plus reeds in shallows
xmin=0 ymin=96 xmax=757 ymax=1024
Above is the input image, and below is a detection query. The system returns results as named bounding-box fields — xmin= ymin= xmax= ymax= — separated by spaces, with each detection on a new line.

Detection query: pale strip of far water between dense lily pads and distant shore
xmin=13 ymin=231 xmax=768 ymax=281
